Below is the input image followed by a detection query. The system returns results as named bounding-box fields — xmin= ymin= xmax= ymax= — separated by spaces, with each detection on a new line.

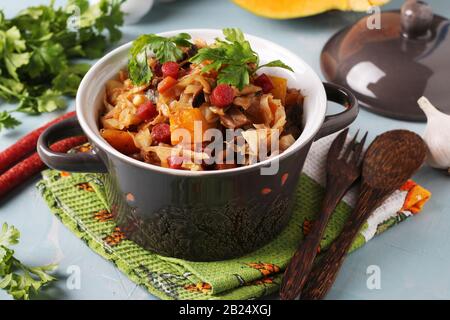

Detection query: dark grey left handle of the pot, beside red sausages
xmin=37 ymin=116 xmax=107 ymax=173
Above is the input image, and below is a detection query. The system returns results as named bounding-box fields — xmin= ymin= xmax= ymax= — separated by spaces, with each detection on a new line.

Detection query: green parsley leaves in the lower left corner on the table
xmin=0 ymin=223 xmax=56 ymax=300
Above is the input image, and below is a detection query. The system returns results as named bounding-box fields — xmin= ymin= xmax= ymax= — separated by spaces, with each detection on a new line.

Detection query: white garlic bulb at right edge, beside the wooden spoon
xmin=418 ymin=97 xmax=450 ymax=170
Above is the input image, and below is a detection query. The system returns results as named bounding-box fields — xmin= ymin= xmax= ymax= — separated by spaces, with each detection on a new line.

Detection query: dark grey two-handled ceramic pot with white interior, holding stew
xmin=38 ymin=29 xmax=358 ymax=261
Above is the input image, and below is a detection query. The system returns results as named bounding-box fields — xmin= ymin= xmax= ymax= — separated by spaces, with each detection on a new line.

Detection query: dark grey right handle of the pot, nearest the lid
xmin=315 ymin=82 xmax=359 ymax=140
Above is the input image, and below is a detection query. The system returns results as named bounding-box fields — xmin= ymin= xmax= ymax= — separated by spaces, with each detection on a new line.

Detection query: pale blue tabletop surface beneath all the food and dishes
xmin=0 ymin=0 xmax=450 ymax=299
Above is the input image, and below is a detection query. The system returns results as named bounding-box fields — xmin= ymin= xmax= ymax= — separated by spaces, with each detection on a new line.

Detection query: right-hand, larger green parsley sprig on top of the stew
xmin=191 ymin=28 xmax=293 ymax=89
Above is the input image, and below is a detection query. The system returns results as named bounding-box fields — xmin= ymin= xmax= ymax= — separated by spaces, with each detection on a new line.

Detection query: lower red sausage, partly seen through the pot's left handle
xmin=0 ymin=136 xmax=87 ymax=197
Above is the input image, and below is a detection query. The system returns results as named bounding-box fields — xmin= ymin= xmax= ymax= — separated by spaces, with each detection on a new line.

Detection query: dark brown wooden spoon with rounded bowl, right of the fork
xmin=301 ymin=130 xmax=426 ymax=300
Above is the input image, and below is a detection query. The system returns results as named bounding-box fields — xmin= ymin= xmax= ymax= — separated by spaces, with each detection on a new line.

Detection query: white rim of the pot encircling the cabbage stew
xmin=75 ymin=29 xmax=327 ymax=177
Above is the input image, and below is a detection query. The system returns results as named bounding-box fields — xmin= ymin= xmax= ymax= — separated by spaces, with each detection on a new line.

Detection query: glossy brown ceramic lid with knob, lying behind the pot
xmin=321 ymin=0 xmax=450 ymax=121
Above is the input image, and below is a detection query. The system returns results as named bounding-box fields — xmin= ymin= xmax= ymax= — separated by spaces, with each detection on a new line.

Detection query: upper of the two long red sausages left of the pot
xmin=0 ymin=111 xmax=75 ymax=173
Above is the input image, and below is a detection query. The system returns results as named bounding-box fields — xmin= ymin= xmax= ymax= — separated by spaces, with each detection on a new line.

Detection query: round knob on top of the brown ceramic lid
xmin=401 ymin=0 xmax=434 ymax=39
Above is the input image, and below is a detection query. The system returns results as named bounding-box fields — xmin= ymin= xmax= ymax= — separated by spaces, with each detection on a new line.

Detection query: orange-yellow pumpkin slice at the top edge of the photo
xmin=232 ymin=0 xmax=390 ymax=19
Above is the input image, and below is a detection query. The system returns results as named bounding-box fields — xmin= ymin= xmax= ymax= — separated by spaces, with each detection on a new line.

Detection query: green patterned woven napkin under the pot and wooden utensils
xmin=38 ymin=166 xmax=423 ymax=299
